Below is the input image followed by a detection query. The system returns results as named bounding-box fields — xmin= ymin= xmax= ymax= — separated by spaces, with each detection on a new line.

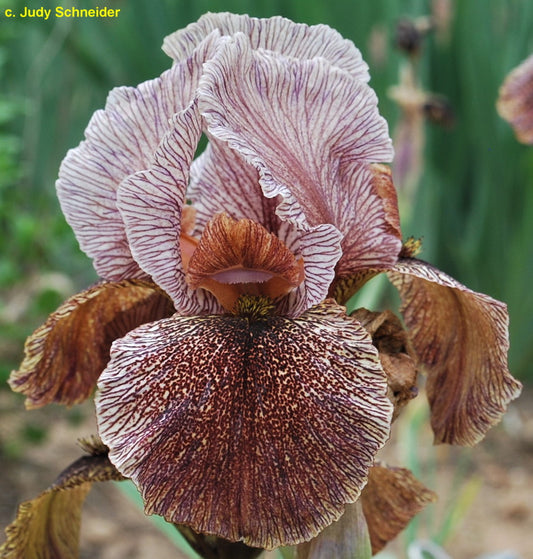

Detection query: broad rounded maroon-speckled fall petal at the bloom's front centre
xmin=97 ymin=302 xmax=392 ymax=548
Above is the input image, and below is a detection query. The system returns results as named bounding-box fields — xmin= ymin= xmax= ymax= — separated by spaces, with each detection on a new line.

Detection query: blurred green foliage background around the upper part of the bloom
xmin=0 ymin=0 xmax=533 ymax=386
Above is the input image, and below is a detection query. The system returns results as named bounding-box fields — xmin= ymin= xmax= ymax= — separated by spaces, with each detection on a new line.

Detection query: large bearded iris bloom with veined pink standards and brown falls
xmin=3 ymin=14 xmax=520 ymax=548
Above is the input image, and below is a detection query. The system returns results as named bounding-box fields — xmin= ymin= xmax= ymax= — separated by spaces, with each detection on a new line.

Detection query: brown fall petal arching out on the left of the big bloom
xmin=9 ymin=280 xmax=174 ymax=408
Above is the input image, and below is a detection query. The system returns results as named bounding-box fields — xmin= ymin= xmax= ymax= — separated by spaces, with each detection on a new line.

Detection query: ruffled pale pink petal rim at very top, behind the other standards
xmin=163 ymin=12 xmax=370 ymax=82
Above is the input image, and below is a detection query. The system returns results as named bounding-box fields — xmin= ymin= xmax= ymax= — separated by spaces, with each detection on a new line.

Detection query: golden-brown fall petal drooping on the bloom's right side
xmin=389 ymin=259 xmax=521 ymax=445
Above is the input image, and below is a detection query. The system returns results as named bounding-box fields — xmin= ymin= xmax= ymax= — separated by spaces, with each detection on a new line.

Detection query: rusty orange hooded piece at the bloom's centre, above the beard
xmin=186 ymin=213 xmax=304 ymax=311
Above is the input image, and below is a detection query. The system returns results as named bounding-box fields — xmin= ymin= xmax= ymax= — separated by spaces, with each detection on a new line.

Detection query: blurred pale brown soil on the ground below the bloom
xmin=0 ymin=390 xmax=533 ymax=559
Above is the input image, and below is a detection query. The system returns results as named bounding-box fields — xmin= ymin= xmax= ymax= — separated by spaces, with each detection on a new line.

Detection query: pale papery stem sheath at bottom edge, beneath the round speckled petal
xmin=295 ymin=504 xmax=372 ymax=559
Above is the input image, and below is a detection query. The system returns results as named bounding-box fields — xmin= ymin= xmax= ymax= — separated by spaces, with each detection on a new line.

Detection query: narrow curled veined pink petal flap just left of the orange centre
xmin=118 ymin=102 xmax=220 ymax=314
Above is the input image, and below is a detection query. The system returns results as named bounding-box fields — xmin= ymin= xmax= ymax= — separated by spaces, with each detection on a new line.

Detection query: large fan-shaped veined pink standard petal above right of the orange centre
xmin=198 ymin=34 xmax=392 ymax=234
